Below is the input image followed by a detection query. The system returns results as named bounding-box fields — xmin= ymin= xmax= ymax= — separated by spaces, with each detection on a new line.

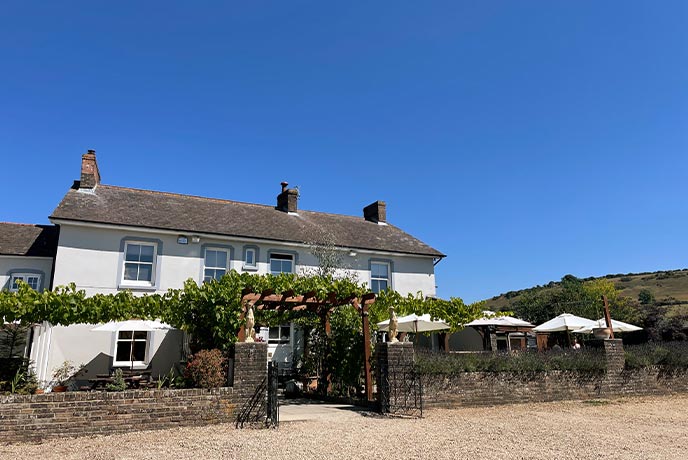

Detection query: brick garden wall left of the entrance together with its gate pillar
xmin=0 ymin=343 xmax=267 ymax=442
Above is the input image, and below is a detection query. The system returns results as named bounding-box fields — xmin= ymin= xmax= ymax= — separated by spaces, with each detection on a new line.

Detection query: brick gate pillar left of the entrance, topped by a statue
xmin=234 ymin=342 xmax=268 ymax=421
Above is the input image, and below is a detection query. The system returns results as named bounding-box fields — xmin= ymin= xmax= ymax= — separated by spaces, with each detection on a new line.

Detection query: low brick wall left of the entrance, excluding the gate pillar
xmin=0 ymin=388 xmax=241 ymax=441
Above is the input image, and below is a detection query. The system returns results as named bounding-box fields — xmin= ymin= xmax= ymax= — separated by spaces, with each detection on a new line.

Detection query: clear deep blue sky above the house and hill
xmin=0 ymin=0 xmax=688 ymax=301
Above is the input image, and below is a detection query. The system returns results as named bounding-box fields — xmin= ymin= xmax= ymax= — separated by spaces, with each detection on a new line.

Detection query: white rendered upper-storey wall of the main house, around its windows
xmin=54 ymin=225 xmax=436 ymax=296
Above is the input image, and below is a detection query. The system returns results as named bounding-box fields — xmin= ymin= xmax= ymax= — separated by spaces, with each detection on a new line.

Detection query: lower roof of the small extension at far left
xmin=0 ymin=222 xmax=59 ymax=257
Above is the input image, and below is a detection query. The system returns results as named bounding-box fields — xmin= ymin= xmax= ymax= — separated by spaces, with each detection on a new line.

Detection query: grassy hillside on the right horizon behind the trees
xmin=486 ymin=269 xmax=688 ymax=311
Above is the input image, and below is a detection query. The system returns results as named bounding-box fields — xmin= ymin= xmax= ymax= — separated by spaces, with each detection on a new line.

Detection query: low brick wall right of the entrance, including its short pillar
xmin=422 ymin=339 xmax=688 ymax=407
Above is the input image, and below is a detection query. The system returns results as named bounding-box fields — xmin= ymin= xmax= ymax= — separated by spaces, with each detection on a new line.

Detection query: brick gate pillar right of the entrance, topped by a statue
xmin=376 ymin=342 xmax=414 ymax=413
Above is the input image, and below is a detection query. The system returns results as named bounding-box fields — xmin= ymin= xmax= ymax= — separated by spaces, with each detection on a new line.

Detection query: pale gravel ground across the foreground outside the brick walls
xmin=0 ymin=395 xmax=688 ymax=460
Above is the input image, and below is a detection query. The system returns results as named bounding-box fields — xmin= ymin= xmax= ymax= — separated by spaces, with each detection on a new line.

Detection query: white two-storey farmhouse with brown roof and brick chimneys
xmin=0 ymin=150 xmax=444 ymax=388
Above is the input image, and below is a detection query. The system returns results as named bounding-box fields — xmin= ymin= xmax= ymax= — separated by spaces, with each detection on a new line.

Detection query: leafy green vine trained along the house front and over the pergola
xmin=0 ymin=270 xmax=483 ymax=349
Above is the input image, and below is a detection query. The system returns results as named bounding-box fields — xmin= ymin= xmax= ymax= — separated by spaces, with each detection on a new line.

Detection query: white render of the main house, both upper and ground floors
xmin=39 ymin=220 xmax=436 ymax=381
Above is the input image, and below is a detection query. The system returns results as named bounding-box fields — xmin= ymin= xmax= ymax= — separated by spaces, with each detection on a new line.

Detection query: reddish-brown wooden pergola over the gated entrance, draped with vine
xmin=237 ymin=289 xmax=375 ymax=401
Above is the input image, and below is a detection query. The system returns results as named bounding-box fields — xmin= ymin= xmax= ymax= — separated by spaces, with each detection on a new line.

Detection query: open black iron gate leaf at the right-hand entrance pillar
xmin=379 ymin=365 xmax=423 ymax=418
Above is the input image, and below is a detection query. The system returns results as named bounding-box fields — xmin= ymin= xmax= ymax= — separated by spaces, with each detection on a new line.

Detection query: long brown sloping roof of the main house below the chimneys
xmin=51 ymin=184 xmax=444 ymax=257
